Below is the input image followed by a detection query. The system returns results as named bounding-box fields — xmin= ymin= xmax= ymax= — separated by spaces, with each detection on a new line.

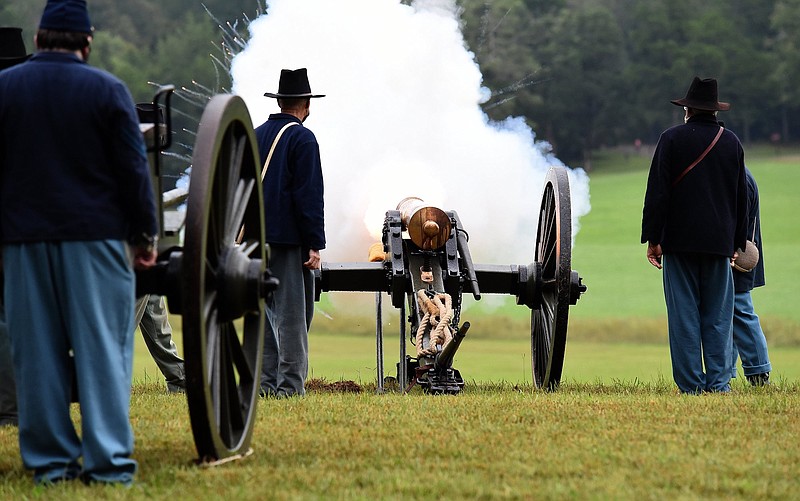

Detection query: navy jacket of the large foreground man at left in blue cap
xmin=0 ymin=52 xmax=158 ymax=243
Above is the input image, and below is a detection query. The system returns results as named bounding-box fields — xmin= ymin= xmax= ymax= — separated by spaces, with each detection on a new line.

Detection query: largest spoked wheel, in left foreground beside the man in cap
xmin=182 ymin=95 xmax=268 ymax=462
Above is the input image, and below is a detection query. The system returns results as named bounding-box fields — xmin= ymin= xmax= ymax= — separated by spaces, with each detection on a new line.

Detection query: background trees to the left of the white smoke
xmin=0 ymin=0 xmax=264 ymax=180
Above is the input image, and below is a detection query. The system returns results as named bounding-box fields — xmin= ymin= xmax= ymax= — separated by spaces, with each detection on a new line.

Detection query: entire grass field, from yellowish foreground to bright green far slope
xmin=0 ymin=145 xmax=800 ymax=501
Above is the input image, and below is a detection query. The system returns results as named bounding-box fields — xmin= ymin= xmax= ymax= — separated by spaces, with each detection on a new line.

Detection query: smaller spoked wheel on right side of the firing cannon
xmin=531 ymin=167 xmax=577 ymax=390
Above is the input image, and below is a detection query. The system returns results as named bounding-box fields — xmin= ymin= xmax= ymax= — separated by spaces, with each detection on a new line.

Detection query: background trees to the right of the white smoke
xmin=459 ymin=0 xmax=800 ymax=165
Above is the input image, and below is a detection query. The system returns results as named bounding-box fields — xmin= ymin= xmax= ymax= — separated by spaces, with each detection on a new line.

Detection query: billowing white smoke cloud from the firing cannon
xmin=231 ymin=0 xmax=590 ymax=264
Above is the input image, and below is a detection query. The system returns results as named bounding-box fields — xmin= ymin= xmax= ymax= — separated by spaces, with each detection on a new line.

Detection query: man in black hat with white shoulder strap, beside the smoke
xmin=255 ymin=68 xmax=325 ymax=397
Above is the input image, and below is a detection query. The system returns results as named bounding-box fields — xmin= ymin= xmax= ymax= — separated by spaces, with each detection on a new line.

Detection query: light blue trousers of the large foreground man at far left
xmin=3 ymin=240 xmax=137 ymax=484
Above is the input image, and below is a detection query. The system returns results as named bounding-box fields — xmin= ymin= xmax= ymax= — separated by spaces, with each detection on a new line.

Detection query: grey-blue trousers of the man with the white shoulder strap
xmin=261 ymin=246 xmax=314 ymax=397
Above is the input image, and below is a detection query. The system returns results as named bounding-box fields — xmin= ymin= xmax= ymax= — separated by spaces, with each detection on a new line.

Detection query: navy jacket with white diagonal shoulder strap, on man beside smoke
xmin=256 ymin=113 xmax=325 ymax=250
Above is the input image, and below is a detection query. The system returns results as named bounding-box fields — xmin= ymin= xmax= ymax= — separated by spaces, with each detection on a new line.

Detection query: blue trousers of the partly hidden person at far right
xmin=731 ymin=291 xmax=772 ymax=377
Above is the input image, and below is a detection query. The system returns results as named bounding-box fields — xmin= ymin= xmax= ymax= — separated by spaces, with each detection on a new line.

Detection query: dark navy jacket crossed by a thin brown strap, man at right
xmin=642 ymin=114 xmax=747 ymax=257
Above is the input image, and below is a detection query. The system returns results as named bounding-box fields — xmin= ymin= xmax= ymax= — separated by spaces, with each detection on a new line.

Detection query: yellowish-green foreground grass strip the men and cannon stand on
xmin=0 ymin=380 xmax=800 ymax=500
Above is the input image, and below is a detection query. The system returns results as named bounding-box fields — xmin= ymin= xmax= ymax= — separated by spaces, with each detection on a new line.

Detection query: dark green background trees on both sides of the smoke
xmin=0 ymin=0 xmax=800 ymax=168
